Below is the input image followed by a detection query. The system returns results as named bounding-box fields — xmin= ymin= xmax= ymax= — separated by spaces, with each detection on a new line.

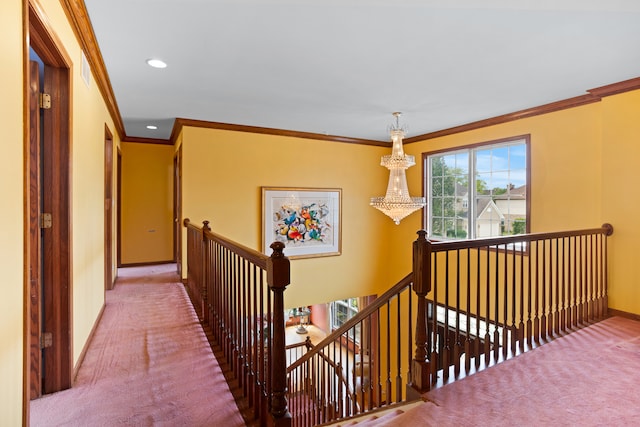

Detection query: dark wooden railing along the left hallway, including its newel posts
xmin=184 ymin=219 xmax=291 ymax=427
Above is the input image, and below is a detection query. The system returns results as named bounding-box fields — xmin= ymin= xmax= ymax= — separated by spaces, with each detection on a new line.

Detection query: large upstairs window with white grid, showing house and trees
xmin=423 ymin=135 xmax=529 ymax=239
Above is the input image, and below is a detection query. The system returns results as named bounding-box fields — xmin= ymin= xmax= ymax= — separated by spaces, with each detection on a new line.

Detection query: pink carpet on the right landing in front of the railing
xmin=340 ymin=317 xmax=640 ymax=427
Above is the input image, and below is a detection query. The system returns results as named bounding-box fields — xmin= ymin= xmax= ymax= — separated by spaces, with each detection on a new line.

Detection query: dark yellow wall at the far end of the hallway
xmin=121 ymin=142 xmax=174 ymax=264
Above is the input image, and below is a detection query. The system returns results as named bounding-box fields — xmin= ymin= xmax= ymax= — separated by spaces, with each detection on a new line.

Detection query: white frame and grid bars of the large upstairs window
xmin=423 ymin=135 xmax=531 ymax=240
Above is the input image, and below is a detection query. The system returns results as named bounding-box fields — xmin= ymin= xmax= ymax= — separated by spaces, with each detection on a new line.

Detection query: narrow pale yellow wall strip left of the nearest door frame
xmin=0 ymin=0 xmax=24 ymax=426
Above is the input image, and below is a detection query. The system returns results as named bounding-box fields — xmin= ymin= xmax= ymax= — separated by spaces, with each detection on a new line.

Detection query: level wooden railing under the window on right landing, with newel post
xmin=414 ymin=224 xmax=613 ymax=392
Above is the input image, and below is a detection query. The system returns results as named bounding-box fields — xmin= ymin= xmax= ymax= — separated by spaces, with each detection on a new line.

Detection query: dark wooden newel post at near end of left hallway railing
xmin=267 ymin=242 xmax=291 ymax=427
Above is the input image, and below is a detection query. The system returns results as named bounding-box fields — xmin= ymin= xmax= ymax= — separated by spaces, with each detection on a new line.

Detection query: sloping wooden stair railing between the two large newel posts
xmin=287 ymin=275 xmax=413 ymax=426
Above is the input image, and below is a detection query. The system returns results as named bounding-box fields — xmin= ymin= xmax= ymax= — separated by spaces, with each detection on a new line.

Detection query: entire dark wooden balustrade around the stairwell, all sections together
xmin=185 ymin=220 xmax=613 ymax=427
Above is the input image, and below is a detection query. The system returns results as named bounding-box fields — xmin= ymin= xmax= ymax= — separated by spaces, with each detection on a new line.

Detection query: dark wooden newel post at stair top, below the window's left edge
xmin=411 ymin=230 xmax=431 ymax=393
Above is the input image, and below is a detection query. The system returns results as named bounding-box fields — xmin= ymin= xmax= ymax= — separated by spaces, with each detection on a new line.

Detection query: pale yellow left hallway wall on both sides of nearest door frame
xmin=0 ymin=0 xmax=119 ymax=426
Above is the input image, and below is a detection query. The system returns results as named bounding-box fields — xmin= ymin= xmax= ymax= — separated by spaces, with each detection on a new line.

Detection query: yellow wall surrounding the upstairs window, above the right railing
xmin=408 ymin=98 xmax=640 ymax=314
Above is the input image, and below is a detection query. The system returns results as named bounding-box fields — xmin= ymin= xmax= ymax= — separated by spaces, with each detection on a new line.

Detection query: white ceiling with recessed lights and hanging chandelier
xmin=85 ymin=0 xmax=640 ymax=140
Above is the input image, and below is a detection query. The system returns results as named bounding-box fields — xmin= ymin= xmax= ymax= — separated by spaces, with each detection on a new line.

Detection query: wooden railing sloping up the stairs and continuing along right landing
xmin=287 ymin=224 xmax=613 ymax=426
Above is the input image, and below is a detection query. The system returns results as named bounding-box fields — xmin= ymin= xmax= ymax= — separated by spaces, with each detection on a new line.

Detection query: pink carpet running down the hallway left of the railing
xmin=31 ymin=264 xmax=245 ymax=427
